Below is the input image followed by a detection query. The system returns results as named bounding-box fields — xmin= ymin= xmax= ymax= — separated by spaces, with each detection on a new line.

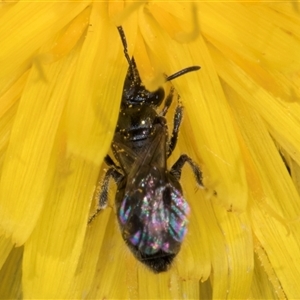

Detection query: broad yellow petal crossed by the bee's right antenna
xmin=141 ymin=4 xmax=247 ymax=211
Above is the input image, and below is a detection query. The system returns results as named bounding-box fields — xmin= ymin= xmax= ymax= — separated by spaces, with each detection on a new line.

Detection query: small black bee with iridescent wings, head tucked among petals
xmin=89 ymin=27 xmax=203 ymax=273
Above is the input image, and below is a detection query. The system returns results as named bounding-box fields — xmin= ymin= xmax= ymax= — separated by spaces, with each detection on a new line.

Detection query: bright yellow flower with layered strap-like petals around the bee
xmin=0 ymin=1 xmax=300 ymax=299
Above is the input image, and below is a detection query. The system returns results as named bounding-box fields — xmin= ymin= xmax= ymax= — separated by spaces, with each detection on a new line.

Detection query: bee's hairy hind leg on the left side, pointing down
xmin=88 ymin=164 xmax=123 ymax=224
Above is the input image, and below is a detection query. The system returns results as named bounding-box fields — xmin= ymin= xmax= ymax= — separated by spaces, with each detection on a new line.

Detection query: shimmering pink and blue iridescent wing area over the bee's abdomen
xmin=118 ymin=176 xmax=190 ymax=255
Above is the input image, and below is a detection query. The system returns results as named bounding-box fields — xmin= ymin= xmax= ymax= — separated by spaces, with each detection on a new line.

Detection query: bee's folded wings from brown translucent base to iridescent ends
xmin=118 ymin=123 xmax=189 ymax=255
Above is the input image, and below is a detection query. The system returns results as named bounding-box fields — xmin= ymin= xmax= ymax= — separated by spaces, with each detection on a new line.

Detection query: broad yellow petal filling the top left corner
xmin=0 ymin=1 xmax=88 ymax=94
